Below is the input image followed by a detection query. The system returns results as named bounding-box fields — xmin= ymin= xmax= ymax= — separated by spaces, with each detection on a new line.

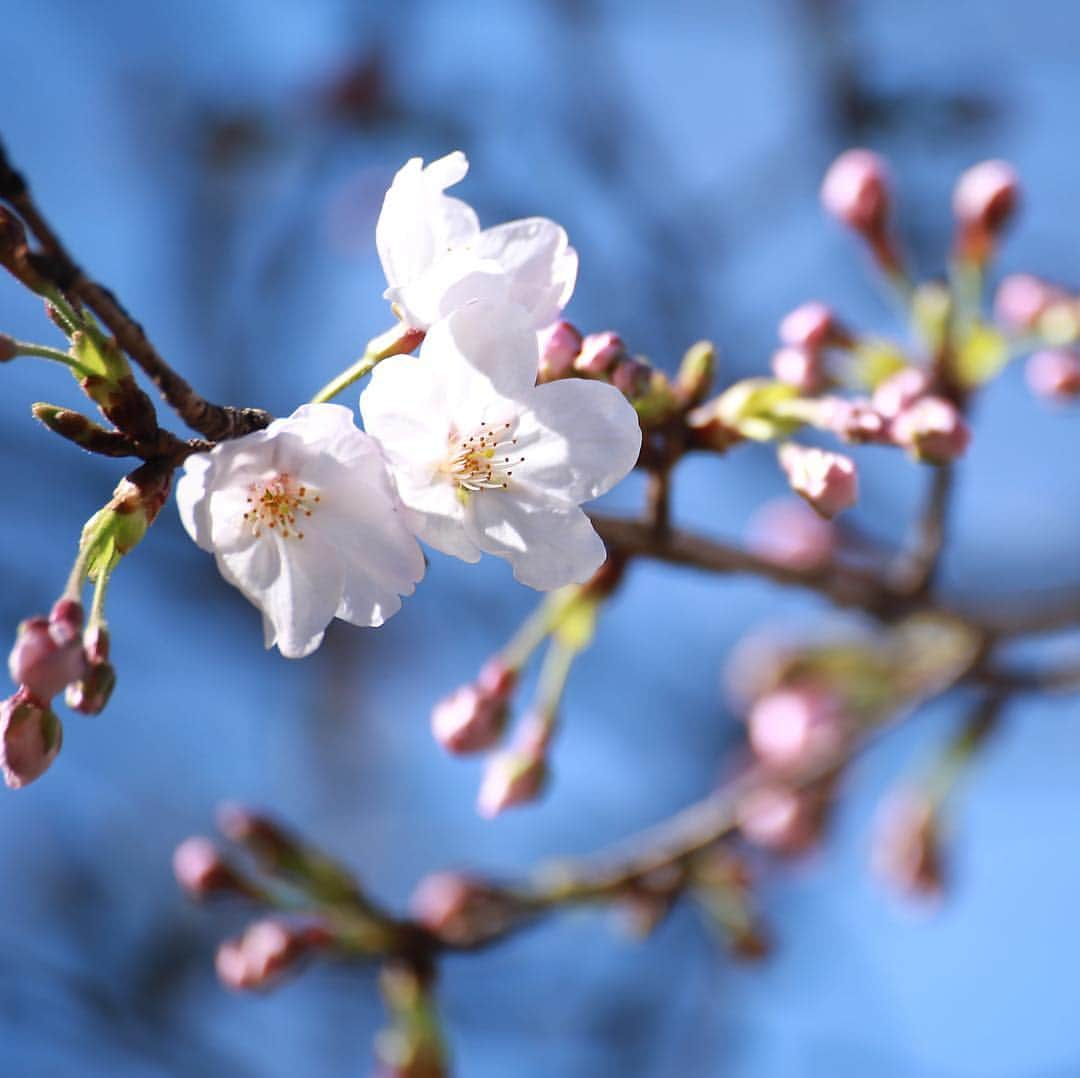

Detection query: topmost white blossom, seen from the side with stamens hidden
xmin=375 ymin=150 xmax=578 ymax=329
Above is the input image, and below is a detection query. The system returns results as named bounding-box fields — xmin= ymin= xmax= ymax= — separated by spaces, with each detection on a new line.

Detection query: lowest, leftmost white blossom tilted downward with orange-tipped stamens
xmin=176 ymin=404 xmax=423 ymax=659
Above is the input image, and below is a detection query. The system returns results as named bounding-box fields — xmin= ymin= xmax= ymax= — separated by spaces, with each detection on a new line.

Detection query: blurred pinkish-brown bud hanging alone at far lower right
xmin=870 ymin=791 xmax=944 ymax=898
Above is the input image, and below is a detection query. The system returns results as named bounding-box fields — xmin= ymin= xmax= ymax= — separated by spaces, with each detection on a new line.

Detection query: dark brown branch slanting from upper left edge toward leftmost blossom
xmin=0 ymin=144 xmax=271 ymax=442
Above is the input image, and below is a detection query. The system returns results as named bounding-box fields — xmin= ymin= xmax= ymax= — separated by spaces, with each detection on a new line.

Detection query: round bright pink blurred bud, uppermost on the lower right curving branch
xmin=746 ymin=686 xmax=845 ymax=769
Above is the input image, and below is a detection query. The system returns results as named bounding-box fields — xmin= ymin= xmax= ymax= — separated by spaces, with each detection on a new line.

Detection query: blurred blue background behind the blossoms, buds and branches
xmin=0 ymin=0 xmax=1080 ymax=1078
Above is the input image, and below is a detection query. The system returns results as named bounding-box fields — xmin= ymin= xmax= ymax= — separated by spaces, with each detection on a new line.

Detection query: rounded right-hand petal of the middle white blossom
xmin=514 ymin=378 xmax=642 ymax=503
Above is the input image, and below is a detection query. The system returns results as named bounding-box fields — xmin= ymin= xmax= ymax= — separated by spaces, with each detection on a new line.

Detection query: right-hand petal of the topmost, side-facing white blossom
xmin=471 ymin=217 xmax=578 ymax=329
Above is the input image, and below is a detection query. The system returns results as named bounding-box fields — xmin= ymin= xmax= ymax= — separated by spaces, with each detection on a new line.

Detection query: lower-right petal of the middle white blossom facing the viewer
xmin=465 ymin=484 xmax=607 ymax=591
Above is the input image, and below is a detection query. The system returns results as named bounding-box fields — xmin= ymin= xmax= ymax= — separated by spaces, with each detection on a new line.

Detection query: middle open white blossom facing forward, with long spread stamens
xmin=360 ymin=304 xmax=642 ymax=590
